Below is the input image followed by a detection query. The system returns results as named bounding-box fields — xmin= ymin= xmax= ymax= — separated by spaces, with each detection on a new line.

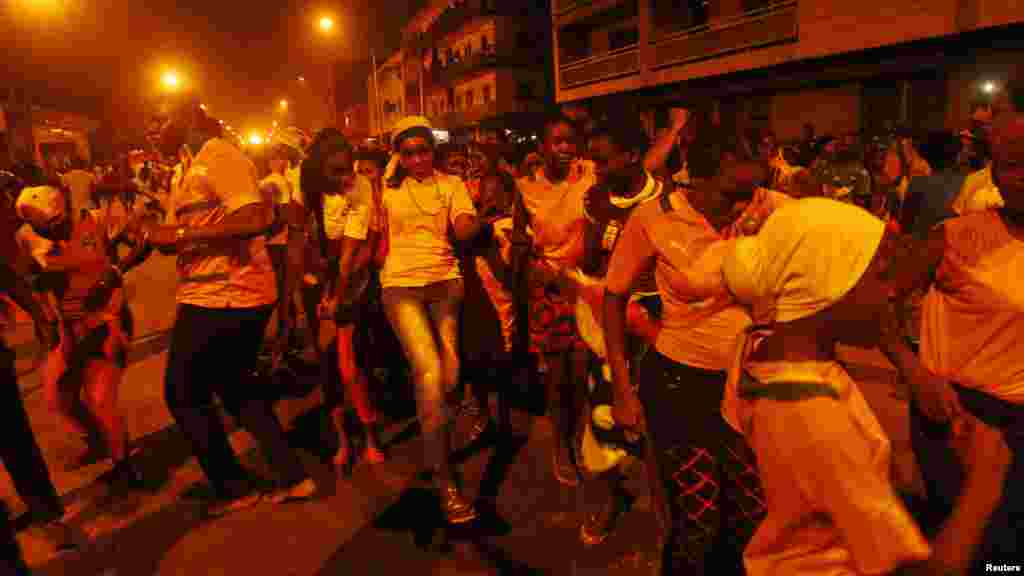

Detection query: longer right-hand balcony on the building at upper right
xmin=651 ymin=0 xmax=798 ymax=69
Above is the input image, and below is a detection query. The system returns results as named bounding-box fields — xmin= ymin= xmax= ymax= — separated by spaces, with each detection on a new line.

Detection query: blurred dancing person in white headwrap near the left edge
xmin=15 ymin=187 xmax=145 ymax=488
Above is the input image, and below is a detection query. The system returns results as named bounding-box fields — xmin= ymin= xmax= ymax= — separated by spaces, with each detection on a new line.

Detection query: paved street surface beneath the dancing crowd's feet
xmin=0 ymin=255 xmax=918 ymax=576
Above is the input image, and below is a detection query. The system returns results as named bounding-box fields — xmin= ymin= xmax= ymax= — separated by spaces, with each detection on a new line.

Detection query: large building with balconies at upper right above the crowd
xmin=551 ymin=0 xmax=1024 ymax=138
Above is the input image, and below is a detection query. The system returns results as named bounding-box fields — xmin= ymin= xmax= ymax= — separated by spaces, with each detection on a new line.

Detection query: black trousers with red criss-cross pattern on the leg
xmin=638 ymin=351 xmax=766 ymax=575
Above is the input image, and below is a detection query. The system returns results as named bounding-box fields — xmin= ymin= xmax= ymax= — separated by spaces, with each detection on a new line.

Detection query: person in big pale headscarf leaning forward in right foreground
xmin=722 ymin=198 xmax=1006 ymax=576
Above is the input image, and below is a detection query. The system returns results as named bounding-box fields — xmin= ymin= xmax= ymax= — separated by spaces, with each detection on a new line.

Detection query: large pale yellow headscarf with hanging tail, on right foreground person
xmin=722 ymin=198 xmax=886 ymax=431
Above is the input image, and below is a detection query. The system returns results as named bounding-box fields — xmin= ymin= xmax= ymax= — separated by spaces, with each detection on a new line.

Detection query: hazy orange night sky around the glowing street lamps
xmin=0 ymin=0 xmax=422 ymax=136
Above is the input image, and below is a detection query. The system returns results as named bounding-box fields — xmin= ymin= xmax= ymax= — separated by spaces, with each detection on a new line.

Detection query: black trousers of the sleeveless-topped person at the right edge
xmin=910 ymin=384 xmax=1024 ymax=574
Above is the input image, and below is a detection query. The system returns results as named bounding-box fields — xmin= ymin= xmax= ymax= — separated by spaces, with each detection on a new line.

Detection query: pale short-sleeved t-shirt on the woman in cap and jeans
xmin=381 ymin=170 xmax=476 ymax=288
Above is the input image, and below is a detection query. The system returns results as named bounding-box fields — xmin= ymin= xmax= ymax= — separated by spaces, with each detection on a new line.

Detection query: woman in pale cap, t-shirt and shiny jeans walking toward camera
xmin=381 ymin=117 xmax=480 ymax=524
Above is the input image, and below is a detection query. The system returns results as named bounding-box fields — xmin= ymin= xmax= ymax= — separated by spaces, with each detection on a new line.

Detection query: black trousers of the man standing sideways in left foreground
xmin=164 ymin=304 xmax=305 ymax=497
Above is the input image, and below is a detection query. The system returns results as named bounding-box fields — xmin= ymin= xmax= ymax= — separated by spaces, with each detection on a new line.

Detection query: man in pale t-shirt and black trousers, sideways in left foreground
xmin=144 ymin=101 xmax=316 ymax=516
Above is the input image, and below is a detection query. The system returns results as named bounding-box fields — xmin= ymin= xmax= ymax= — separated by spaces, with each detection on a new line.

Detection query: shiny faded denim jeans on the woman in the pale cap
xmin=382 ymin=279 xmax=464 ymax=468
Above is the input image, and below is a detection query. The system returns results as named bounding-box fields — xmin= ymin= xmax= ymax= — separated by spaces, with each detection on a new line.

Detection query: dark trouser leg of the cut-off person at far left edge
xmin=0 ymin=344 xmax=65 ymax=524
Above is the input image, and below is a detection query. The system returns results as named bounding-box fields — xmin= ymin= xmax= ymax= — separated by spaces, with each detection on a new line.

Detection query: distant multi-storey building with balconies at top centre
xmin=371 ymin=0 xmax=553 ymax=139
